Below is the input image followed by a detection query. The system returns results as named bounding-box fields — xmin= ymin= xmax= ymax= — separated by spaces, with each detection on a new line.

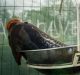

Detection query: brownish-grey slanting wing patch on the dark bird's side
xmin=19 ymin=28 xmax=38 ymax=50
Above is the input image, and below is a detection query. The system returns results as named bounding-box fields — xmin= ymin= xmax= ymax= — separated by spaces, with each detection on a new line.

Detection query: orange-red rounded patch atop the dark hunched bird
xmin=6 ymin=18 xmax=21 ymax=31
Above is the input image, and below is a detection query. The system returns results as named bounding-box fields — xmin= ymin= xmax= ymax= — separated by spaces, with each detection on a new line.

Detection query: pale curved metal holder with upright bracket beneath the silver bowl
xmin=27 ymin=53 xmax=80 ymax=69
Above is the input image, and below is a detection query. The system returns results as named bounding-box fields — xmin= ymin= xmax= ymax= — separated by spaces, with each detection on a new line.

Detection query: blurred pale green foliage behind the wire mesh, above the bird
xmin=0 ymin=0 xmax=76 ymax=44
